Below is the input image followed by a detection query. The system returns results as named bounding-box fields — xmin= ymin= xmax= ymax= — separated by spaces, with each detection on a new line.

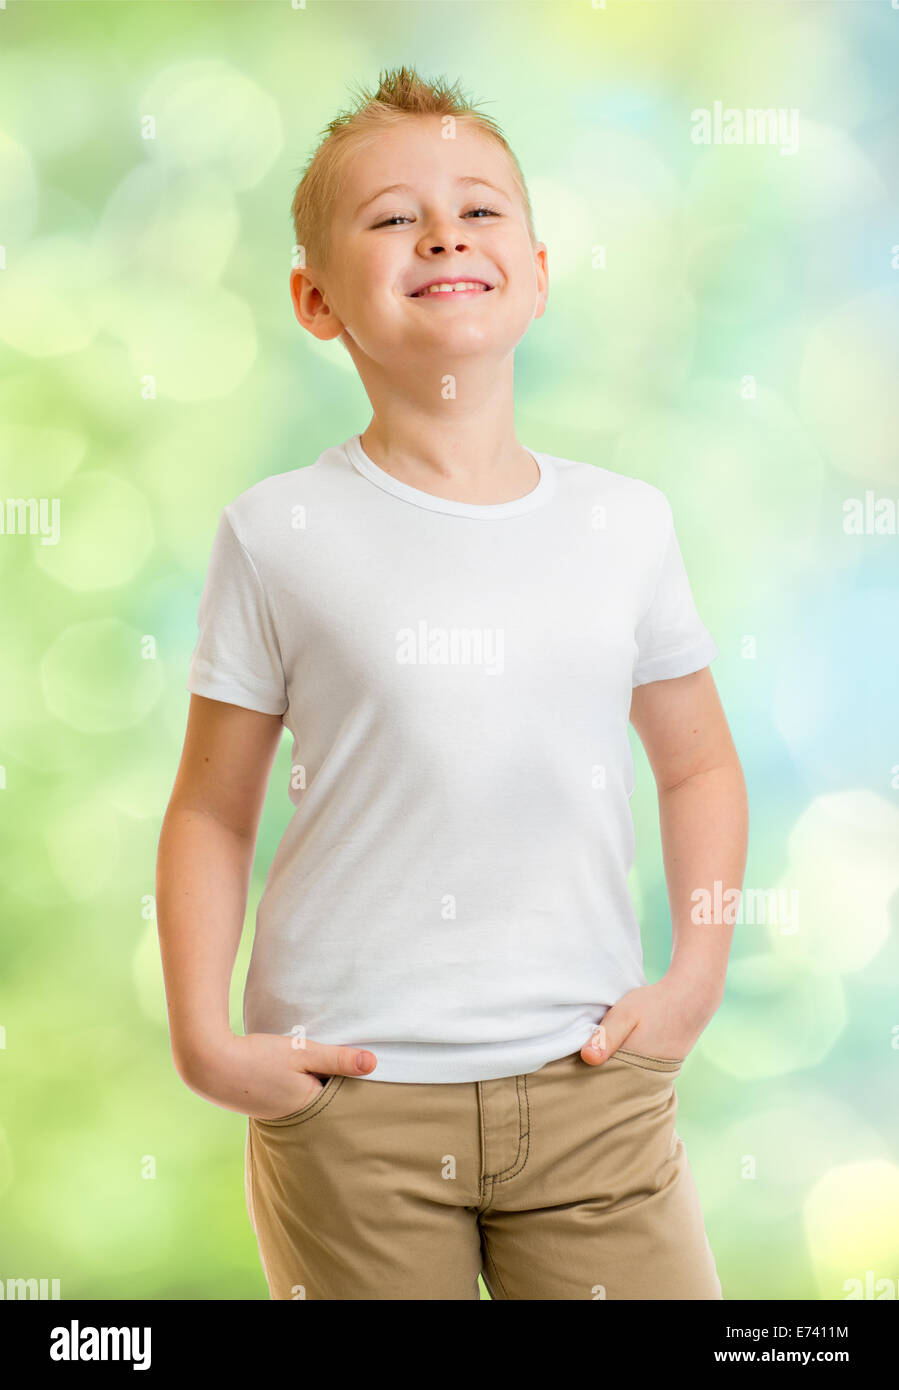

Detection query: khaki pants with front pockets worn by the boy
xmin=246 ymin=1049 xmax=723 ymax=1300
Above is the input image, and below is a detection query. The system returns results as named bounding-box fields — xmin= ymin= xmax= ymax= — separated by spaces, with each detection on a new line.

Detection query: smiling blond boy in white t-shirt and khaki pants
xmin=157 ymin=68 xmax=748 ymax=1300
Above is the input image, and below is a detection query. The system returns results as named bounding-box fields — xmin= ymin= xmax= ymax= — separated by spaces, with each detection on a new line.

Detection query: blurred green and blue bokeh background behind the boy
xmin=0 ymin=0 xmax=899 ymax=1298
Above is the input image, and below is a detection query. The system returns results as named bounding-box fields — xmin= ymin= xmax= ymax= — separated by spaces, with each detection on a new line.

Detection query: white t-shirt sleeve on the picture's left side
xmin=188 ymin=507 xmax=288 ymax=714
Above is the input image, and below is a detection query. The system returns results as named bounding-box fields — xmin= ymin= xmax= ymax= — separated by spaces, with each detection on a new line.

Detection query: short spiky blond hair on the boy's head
xmin=290 ymin=67 xmax=536 ymax=278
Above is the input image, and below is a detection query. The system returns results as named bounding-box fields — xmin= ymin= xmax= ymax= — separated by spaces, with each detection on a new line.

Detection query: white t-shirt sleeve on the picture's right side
xmin=632 ymin=498 xmax=718 ymax=685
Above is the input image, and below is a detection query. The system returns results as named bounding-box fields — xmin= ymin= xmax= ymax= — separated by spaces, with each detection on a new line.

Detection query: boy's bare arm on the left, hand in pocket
xmin=156 ymin=695 xmax=377 ymax=1119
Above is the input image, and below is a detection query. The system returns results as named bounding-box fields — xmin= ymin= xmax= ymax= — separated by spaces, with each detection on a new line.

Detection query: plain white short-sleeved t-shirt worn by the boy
xmin=188 ymin=435 xmax=718 ymax=1081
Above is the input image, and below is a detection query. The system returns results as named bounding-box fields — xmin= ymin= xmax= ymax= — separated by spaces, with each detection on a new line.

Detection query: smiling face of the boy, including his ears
xmin=290 ymin=117 xmax=549 ymax=375
